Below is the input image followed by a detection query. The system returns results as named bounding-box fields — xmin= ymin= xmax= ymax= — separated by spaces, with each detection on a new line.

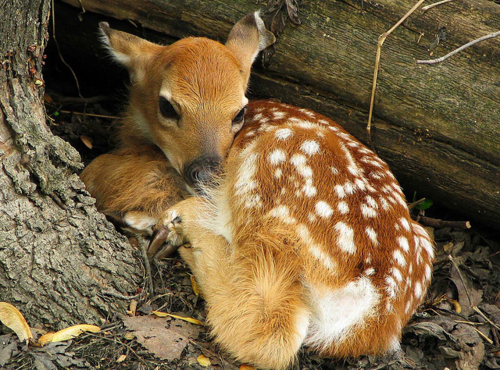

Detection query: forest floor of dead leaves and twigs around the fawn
xmin=0 ymin=93 xmax=500 ymax=370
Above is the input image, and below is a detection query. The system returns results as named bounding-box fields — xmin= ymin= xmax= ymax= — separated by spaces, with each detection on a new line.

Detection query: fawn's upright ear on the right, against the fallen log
xmin=226 ymin=12 xmax=276 ymax=80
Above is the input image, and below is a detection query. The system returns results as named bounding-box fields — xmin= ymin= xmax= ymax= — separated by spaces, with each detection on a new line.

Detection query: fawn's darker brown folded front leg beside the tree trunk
xmin=81 ymin=147 xmax=185 ymax=234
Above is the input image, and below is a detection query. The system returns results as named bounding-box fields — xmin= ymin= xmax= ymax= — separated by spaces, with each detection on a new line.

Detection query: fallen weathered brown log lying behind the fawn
xmin=58 ymin=0 xmax=500 ymax=227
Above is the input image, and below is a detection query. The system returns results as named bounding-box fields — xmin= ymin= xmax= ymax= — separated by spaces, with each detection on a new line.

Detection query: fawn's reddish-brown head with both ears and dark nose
xmin=100 ymin=13 xmax=275 ymax=191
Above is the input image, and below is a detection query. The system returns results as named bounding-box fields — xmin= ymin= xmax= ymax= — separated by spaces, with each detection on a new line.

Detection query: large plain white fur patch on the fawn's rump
xmin=305 ymin=276 xmax=380 ymax=348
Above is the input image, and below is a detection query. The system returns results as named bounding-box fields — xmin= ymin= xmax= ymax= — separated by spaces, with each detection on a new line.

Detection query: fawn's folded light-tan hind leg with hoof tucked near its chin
xmin=154 ymin=197 xmax=309 ymax=369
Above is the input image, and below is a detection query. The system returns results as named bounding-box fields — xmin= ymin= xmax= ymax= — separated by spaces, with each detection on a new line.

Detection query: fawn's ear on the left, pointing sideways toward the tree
xmin=99 ymin=22 xmax=161 ymax=80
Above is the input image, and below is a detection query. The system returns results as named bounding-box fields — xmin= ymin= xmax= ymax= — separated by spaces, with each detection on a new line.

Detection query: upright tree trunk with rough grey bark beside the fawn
xmin=0 ymin=0 xmax=142 ymax=327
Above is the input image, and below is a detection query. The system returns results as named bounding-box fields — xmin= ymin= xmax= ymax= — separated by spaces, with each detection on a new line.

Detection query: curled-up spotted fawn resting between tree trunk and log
xmin=82 ymin=13 xmax=434 ymax=369
